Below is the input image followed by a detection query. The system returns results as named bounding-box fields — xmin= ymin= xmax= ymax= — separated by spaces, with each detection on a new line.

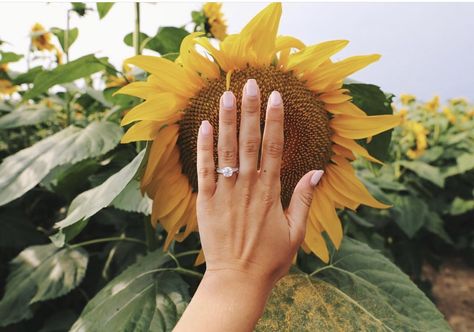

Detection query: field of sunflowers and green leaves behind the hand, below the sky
xmin=0 ymin=3 xmax=474 ymax=332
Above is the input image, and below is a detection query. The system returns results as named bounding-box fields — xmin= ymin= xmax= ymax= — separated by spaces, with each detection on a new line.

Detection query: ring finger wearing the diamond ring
xmin=217 ymin=91 xmax=237 ymax=184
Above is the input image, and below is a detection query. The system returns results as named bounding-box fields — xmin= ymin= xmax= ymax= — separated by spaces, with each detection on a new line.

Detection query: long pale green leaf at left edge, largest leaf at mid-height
xmin=0 ymin=122 xmax=123 ymax=205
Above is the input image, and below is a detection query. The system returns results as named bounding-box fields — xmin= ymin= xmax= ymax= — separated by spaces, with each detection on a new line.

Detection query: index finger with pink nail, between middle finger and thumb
xmin=260 ymin=91 xmax=283 ymax=186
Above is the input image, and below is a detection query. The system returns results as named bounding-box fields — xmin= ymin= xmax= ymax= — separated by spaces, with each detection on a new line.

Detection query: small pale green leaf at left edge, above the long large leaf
xmin=0 ymin=105 xmax=55 ymax=129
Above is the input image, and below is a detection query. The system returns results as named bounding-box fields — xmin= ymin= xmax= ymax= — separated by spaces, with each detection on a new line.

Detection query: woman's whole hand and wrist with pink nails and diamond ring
xmin=176 ymin=79 xmax=323 ymax=331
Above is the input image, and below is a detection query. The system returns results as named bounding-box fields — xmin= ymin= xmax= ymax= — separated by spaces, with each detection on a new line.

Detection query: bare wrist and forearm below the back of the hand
xmin=174 ymin=271 xmax=272 ymax=332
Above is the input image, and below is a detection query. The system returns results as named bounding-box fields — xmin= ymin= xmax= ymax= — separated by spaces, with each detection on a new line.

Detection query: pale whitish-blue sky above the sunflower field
xmin=0 ymin=2 xmax=474 ymax=100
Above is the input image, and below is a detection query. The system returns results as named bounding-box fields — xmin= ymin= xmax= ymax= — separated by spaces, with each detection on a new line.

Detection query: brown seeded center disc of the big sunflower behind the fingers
xmin=178 ymin=67 xmax=331 ymax=208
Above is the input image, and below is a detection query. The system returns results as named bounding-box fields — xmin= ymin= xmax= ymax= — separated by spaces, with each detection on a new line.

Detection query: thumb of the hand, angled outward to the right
xmin=286 ymin=170 xmax=324 ymax=248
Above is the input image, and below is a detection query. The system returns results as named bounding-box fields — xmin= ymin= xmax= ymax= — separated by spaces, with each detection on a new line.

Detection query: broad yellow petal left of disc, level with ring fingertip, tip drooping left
xmin=121 ymin=92 xmax=184 ymax=126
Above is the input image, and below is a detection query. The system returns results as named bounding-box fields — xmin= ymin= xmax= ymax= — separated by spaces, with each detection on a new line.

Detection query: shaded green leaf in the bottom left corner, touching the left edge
xmin=0 ymin=244 xmax=88 ymax=326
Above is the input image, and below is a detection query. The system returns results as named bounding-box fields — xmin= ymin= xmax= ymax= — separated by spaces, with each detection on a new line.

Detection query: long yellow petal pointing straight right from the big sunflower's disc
xmin=329 ymin=114 xmax=402 ymax=139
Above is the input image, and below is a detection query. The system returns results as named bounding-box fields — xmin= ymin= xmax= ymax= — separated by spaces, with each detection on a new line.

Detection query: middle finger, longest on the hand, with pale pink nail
xmin=239 ymin=79 xmax=261 ymax=179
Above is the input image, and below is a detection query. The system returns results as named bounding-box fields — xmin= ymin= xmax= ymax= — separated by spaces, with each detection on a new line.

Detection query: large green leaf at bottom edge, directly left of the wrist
xmin=70 ymin=250 xmax=189 ymax=332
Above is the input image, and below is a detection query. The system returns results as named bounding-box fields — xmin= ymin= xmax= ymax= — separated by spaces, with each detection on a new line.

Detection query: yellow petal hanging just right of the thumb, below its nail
xmin=309 ymin=187 xmax=343 ymax=248
